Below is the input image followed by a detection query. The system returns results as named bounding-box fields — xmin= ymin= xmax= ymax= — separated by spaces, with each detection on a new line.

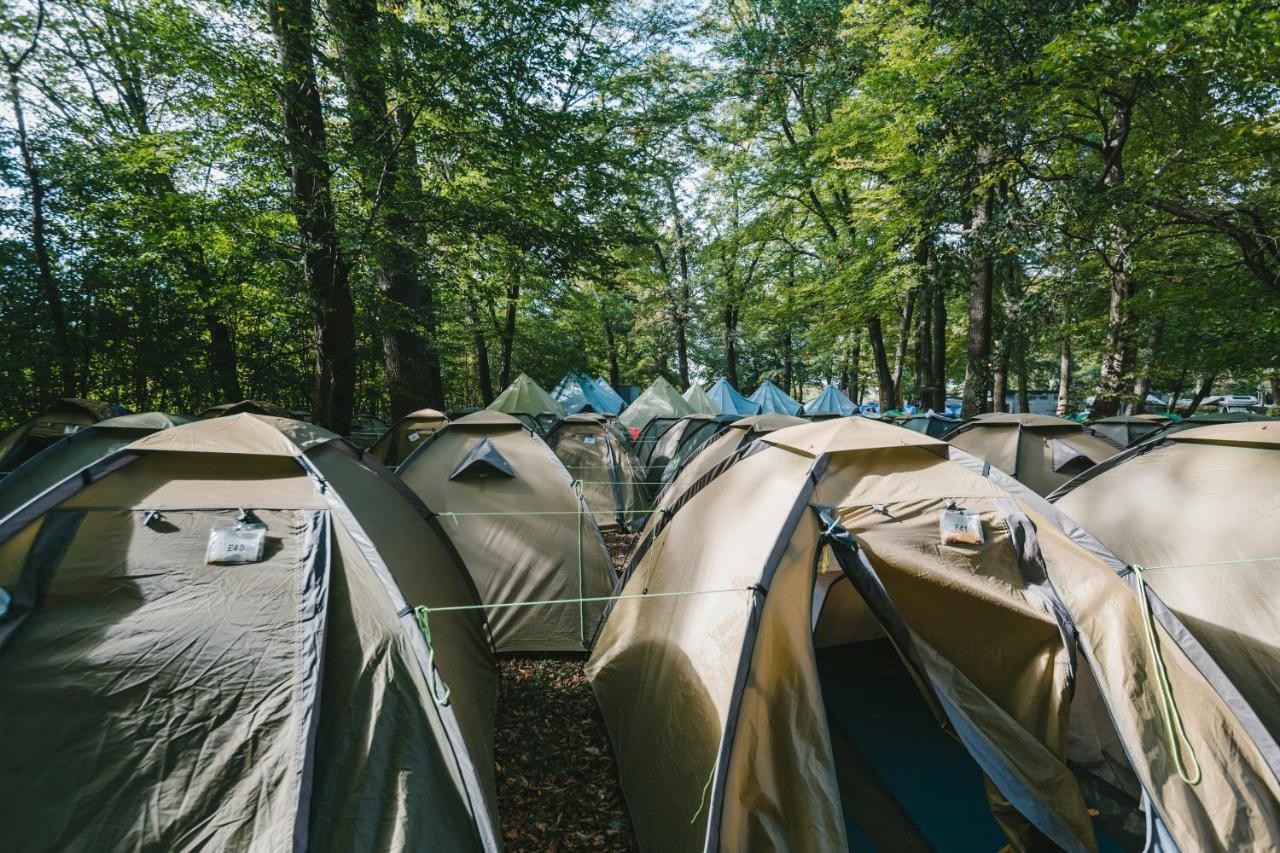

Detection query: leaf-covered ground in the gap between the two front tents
xmin=495 ymin=534 xmax=637 ymax=853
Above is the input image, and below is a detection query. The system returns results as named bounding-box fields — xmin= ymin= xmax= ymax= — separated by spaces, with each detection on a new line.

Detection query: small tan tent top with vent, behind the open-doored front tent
xmin=943 ymin=414 xmax=1120 ymax=494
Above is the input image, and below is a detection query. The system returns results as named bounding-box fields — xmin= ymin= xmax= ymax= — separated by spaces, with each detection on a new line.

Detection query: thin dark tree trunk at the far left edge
xmin=4 ymin=58 xmax=76 ymax=397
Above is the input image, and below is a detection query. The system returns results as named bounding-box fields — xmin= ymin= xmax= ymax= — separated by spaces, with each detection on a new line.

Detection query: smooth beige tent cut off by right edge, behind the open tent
xmin=1050 ymin=423 xmax=1280 ymax=739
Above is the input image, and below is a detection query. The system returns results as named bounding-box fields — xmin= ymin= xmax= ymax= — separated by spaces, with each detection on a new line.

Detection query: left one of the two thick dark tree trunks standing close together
xmin=266 ymin=0 xmax=356 ymax=434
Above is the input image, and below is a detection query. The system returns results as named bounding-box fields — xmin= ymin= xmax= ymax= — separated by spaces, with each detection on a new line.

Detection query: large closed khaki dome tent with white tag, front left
xmin=0 ymin=415 xmax=498 ymax=850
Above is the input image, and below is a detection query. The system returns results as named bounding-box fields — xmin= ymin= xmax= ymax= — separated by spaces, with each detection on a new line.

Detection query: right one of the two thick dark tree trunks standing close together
xmin=328 ymin=0 xmax=443 ymax=418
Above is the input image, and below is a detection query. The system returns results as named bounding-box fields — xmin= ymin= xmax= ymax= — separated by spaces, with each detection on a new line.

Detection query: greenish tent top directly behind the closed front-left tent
xmin=0 ymin=411 xmax=191 ymax=520
